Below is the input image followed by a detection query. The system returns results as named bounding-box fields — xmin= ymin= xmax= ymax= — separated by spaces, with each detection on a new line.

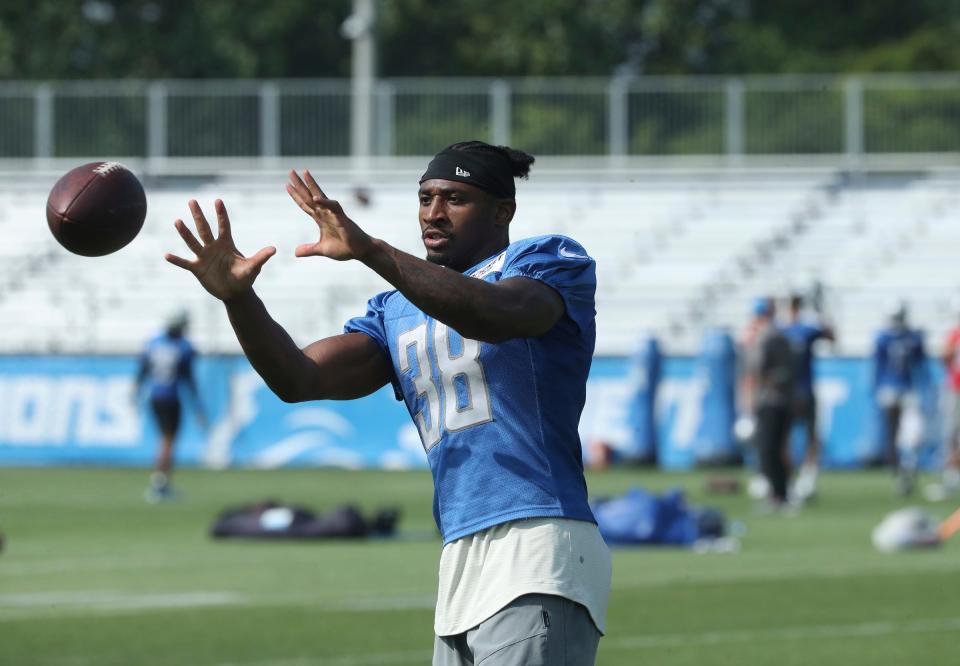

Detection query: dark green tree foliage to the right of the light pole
xmin=379 ymin=0 xmax=960 ymax=76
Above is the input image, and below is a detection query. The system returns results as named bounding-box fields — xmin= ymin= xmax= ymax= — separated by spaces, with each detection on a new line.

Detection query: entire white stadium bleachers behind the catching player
xmin=0 ymin=172 xmax=960 ymax=355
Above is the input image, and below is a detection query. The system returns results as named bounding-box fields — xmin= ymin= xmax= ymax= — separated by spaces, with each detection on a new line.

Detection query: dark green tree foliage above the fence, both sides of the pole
xmin=0 ymin=0 xmax=960 ymax=79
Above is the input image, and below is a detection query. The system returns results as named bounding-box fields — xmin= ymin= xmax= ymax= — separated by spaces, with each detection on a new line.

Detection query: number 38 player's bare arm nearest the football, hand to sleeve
xmin=165 ymin=200 xmax=390 ymax=402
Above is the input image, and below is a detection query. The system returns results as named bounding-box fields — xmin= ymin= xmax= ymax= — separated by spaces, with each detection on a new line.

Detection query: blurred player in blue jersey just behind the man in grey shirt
xmin=783 ymin=294 xmax=836 ymax=502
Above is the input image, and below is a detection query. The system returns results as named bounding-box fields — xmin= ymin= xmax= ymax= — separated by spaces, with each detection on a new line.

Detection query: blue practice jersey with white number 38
xmin=344 ymin=236 xmax=596 ymax=543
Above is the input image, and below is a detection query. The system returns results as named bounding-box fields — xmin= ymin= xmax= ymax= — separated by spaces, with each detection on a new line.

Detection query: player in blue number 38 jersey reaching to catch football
xmin=166 ymin=141 xmax=611 ymax=666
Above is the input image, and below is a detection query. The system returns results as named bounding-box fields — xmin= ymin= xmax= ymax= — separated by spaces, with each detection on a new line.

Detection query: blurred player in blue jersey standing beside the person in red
xmin=873 ymin=301 xmax=929 ymax=495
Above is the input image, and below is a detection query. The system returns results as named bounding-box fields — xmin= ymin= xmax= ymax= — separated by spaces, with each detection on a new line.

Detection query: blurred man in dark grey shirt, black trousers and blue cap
xmin=741 ymin=298 xmax=796 ymax=510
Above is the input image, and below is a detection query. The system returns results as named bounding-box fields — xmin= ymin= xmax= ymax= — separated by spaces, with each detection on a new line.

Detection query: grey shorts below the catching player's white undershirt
xmin=433 ymin=594 xmax=600 ymax=666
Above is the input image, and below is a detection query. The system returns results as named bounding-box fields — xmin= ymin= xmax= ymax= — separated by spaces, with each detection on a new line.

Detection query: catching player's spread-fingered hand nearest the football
xmin=164 ymin=199 xmax=277 ymax=301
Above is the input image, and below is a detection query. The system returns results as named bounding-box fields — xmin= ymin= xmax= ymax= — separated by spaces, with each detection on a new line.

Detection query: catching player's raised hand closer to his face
xmin=287 ymin=171 xmax=373 ymax=261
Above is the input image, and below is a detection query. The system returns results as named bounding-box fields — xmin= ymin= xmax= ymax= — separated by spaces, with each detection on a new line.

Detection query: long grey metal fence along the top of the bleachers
xmin=0 ymin=74 xmax=960 ymax=163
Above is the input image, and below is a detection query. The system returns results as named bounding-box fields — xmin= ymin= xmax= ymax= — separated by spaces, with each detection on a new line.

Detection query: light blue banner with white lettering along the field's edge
xmin=0 ymin=356 xmax=942 ymax=470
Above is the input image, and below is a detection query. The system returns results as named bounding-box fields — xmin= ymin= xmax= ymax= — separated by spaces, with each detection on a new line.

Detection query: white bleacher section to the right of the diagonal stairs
xmin=711 ymin=177 xmax=960 ymax=355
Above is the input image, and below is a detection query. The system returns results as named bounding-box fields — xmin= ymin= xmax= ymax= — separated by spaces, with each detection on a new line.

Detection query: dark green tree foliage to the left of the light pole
xmin=0 ymin=0 xmax=350 ymax=79
